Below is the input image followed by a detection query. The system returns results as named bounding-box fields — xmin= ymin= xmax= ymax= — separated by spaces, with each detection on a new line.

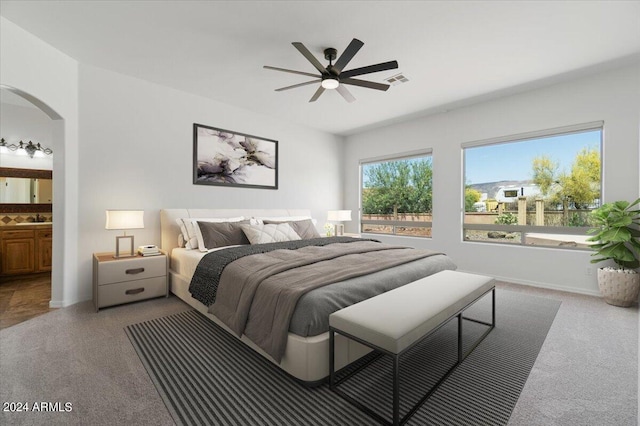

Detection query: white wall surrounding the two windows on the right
xmin=344 ymin=65 xmax=640 ymax=294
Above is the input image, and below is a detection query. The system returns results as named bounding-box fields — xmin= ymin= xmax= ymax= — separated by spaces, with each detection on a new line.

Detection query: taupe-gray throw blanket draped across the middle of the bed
xmin=209 ymin=239 xmax=441 ymax=363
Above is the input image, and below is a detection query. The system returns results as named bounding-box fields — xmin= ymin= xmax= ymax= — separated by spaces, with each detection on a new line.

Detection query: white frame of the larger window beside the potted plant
xmin=461 ymin=121 xmax=605 ymax=251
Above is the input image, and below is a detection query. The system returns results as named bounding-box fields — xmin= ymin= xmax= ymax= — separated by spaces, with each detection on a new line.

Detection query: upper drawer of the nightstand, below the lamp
xmin=98 ymin=256 xmax=167 ymax=284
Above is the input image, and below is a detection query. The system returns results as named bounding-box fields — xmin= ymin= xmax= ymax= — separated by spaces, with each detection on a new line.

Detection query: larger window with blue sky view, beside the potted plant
xmin=463 ymin=122 xmax=602 ymax=248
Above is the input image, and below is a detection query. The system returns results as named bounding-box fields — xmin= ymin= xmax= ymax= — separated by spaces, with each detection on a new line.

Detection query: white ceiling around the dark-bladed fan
xmin=0 ymin=0 xmax=640 ymax=134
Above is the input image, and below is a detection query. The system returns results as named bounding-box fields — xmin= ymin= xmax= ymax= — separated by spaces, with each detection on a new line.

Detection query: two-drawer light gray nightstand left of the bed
xmin=93 ymin=253 xmax=169 ymax=312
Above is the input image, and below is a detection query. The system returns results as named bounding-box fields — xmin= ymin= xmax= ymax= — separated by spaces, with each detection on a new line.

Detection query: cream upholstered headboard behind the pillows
xmin=160 ymin=209 xmax=311 ymax=254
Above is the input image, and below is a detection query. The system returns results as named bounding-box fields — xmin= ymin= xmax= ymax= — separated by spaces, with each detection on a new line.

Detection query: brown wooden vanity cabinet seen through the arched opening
xmin=0 ymin=225 xmax=53 ymax=275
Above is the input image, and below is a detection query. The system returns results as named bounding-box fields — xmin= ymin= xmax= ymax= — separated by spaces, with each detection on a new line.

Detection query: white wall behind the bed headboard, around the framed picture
xmin=78 ymin=65 xmax=342 ymax=298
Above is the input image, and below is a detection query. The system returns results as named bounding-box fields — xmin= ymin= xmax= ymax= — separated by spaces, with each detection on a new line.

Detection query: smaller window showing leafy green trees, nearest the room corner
xmin=360 ymin=152 xmax=433 ymax=237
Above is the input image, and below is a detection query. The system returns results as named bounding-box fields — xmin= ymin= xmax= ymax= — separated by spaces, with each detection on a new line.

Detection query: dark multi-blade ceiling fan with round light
xmin=264 ymin=38 xmax=398 ymax=102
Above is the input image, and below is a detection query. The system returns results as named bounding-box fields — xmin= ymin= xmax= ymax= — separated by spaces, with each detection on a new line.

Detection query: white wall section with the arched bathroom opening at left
xmin=0 ymin=17 xmax=82 ymax=307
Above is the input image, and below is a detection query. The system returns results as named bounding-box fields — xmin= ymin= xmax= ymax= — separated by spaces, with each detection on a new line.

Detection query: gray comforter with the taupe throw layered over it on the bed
xmin=194 ymin=240 xmax=455 ymax=362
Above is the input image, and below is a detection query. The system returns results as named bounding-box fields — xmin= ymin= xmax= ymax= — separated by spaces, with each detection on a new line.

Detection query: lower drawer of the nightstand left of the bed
xmin=98 ymin=276 xmax=167 ymax=308
